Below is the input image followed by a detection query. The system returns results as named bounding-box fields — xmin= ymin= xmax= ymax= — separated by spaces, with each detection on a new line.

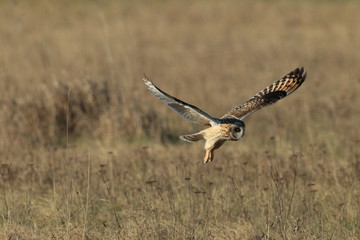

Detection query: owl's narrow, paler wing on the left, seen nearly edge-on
xmin=143 ymin=76 xmax=220 ymax=126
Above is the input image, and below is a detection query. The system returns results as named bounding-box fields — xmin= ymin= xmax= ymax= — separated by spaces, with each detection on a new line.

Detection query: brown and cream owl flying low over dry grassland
xmin=143 ymin=67 xmax=306 ymax=163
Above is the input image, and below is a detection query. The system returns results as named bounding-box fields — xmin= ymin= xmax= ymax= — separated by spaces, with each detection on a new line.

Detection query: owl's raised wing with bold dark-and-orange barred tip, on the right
xmin=221 ymin=67 xmax=306 ymax=120
